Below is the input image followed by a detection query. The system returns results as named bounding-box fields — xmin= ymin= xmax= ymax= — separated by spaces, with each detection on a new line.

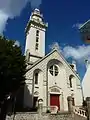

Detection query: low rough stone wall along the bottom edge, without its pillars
xmin=6 ymin=112 xmax=87 ymax=120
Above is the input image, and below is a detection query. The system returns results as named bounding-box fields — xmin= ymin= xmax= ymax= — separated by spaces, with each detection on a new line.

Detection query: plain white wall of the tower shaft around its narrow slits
xmin=25 ymin=27 xmax=45 ymax=57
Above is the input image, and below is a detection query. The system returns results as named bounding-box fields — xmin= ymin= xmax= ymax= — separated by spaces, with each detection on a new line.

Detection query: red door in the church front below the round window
xmin=50 ymin=94 xmax=60 ymax=110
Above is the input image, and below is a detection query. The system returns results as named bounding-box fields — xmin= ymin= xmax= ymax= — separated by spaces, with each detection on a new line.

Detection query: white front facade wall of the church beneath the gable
xmin=23 ymin=51 xmax=82 ymax=110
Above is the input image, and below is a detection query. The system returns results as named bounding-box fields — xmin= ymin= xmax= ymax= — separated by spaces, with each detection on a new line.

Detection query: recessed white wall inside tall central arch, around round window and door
xmin=47 ymin=60 xmax=66 ymax=110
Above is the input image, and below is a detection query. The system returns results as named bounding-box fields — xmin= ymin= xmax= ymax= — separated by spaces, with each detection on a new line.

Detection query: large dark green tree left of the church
xmin=0 ymin=36 xmax=26 ymax=120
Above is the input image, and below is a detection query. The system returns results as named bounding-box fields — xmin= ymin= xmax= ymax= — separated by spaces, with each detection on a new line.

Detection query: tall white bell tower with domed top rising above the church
xmin=25 ymin=9 xmax=48 ymax=63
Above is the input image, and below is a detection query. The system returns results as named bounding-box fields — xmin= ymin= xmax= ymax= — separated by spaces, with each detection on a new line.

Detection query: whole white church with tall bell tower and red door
xmin=24 ymin=9 xmax=83 ymax=111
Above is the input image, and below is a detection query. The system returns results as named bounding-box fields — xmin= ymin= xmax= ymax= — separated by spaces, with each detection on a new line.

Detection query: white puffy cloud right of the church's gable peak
xmin=51 ymin=42 xmax=90 ymax=61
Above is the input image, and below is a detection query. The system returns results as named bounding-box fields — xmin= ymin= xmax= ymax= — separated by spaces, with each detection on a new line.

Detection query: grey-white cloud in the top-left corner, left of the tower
xmin=0 ymin=0 xmax=42 ymax=34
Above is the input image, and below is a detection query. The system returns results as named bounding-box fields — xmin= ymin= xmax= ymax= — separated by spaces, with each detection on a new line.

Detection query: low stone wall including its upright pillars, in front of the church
xmin=6 ymin=96 xmax=89 ymax=120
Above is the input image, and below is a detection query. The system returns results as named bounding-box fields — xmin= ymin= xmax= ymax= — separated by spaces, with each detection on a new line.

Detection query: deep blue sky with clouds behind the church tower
xmin=0 ymin=0 xmax=90 ymax=79
